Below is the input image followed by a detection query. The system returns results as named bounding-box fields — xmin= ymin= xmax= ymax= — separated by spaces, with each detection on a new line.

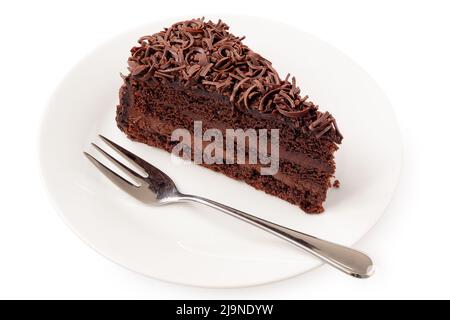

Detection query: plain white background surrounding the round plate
xmin=0 ymin=0 xmax=450 ymax=299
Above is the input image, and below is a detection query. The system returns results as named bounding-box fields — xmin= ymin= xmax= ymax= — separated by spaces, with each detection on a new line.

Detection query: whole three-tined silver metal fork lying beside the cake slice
xmin=84 ymin=135 xmax=374 ymax=278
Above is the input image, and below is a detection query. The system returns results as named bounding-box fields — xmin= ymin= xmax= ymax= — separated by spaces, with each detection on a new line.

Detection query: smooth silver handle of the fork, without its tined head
xmin=179 ymin=195 xmax=374 ymax=278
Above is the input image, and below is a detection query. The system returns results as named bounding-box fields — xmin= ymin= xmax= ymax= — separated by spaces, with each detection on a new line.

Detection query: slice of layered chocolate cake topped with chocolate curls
xmin=116 ymin=19 xmax=342 ymax=213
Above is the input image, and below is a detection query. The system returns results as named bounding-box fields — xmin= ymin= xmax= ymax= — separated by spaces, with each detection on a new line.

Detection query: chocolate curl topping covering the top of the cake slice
xmin=128 ymin=18 xmax=342 ymax=143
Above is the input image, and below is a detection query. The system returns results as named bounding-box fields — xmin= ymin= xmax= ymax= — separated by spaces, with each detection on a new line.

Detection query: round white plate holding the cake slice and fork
xmin=40 ymin=16 xmax=401 ymax=287
